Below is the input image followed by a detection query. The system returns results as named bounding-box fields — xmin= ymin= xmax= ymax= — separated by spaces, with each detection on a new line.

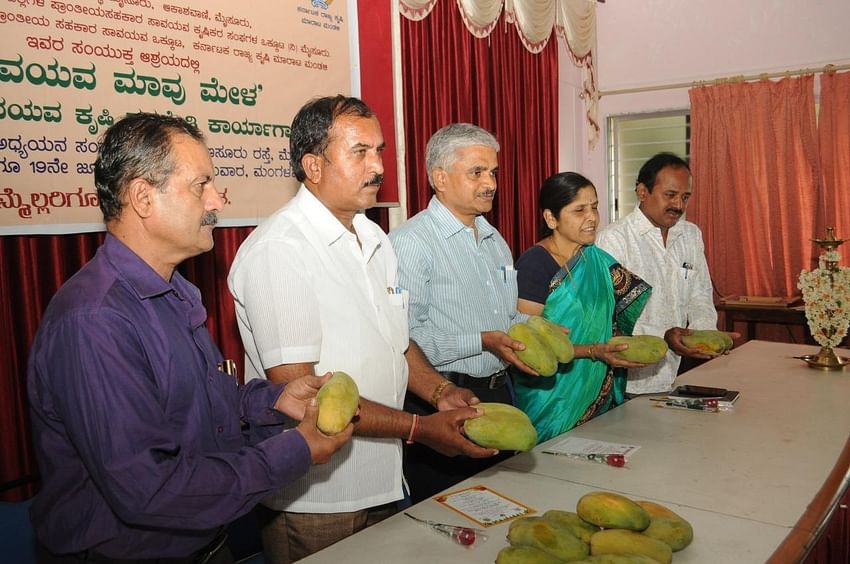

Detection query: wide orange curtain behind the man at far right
xmin=688 ymin=76 xmax=820 ymax=296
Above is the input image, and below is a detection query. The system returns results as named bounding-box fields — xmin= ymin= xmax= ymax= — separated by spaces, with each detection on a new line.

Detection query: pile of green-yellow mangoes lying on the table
xmin=496 ymin=491 xmax=694 ymax=564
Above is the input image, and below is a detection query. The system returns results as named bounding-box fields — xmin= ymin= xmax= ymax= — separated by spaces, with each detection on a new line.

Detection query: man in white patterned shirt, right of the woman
xmin=596 ymin=153 xmax=717 ymax=395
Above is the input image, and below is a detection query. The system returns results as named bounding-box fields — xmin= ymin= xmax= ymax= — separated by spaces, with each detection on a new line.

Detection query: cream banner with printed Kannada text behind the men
xmin=0 ymin=0 xmax=357 ymax=235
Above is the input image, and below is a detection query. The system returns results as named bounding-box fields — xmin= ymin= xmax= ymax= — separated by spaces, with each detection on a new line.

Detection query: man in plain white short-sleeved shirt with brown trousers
xmin=228 ymin=96 xmax=497 ymax=564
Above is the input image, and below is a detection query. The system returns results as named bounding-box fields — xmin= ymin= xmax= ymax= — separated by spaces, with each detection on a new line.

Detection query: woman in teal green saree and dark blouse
xmin=514 ymin=172 xmax=651 ymax=442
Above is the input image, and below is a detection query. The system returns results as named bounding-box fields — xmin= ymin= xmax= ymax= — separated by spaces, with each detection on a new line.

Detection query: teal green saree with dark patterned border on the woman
xmin=515 ymin=245 xmax=651 ymax=442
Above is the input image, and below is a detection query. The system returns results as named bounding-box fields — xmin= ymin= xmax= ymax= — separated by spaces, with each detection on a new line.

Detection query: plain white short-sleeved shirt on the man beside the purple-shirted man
xmin=228 ymin=186 xmax=408 ymax=513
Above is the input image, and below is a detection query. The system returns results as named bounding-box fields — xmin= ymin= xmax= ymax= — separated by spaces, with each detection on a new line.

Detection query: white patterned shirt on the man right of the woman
xmin=596 ymin=208 xmax=717 ymax=394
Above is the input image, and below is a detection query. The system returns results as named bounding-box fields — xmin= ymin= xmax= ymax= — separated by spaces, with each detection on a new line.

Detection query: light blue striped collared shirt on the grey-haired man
xmin=390 ymin=196 xmax=527 ymax=377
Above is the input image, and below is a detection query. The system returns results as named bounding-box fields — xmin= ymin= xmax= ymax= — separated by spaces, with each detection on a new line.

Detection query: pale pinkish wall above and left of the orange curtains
xmin=561 ymin=0 xmax=850 ymax=222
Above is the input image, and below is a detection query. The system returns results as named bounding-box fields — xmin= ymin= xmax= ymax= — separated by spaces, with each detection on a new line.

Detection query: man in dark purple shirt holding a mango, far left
xmin=28 ymin=114 xmax=353 ymax=563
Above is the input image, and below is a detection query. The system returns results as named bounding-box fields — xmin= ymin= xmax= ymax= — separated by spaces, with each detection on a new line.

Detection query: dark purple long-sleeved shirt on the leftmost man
xmin=28 ymin=235 xmax=310 ymax=558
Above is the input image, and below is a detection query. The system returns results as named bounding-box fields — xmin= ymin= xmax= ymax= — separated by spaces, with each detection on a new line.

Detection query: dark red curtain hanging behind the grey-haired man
xmin=401 ymin=0 xmax=558 ymax=255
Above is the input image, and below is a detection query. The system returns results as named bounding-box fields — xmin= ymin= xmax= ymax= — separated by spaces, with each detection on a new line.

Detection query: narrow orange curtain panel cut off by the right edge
xmin=815 ymin=72 xmax=850 ymax=258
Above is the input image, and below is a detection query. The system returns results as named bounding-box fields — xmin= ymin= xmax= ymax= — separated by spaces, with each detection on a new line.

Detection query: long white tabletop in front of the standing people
xmin=303 ymin=341 xmax=850 ymax=564
